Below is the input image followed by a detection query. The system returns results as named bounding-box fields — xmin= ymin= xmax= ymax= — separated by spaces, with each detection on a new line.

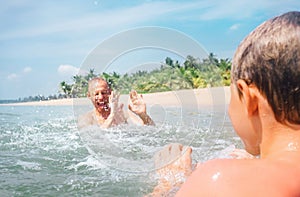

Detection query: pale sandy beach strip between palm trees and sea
xmin=0 ymin=87 xmax=230 ymax=106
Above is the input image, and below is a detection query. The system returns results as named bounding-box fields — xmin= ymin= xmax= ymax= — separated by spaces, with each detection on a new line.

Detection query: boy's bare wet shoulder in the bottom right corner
xmin=177 ymin=159 xmax=300 ymax=196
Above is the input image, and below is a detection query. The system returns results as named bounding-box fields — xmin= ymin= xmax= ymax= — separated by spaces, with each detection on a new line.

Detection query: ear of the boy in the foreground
xmin=237 ymin=79 xmax=258 ymax=116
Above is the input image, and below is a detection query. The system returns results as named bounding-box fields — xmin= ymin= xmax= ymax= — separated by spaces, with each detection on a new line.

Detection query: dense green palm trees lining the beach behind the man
xmin=60 ymin=53 xmax=231 ymax=98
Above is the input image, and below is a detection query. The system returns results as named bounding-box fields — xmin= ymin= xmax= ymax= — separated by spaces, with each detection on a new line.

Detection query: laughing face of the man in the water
xmin=89 ymin=81 xmax=111 ymax=111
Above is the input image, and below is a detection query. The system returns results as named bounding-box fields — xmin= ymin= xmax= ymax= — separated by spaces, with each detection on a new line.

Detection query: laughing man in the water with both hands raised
xmin=78 ymin=77 xmax=154 ymax=128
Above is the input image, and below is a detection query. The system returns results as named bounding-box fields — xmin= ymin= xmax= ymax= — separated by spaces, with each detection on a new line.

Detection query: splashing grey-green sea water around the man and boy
xmin=0 ymin=106 xmax=240 ymax=197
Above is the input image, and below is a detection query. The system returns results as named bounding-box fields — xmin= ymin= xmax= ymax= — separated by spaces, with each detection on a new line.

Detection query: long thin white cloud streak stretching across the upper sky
xmin=0 ymin=0 xmax=300 ymax=40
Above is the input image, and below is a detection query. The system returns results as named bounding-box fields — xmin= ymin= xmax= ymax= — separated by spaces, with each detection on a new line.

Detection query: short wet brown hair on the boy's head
xmin=231 ymin=11 xmax=300 ymax=124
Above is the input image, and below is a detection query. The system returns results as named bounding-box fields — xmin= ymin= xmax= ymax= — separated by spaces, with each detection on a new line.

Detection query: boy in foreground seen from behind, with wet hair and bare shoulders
xmin=151 ymin=12 xmax=300 ymax=197
